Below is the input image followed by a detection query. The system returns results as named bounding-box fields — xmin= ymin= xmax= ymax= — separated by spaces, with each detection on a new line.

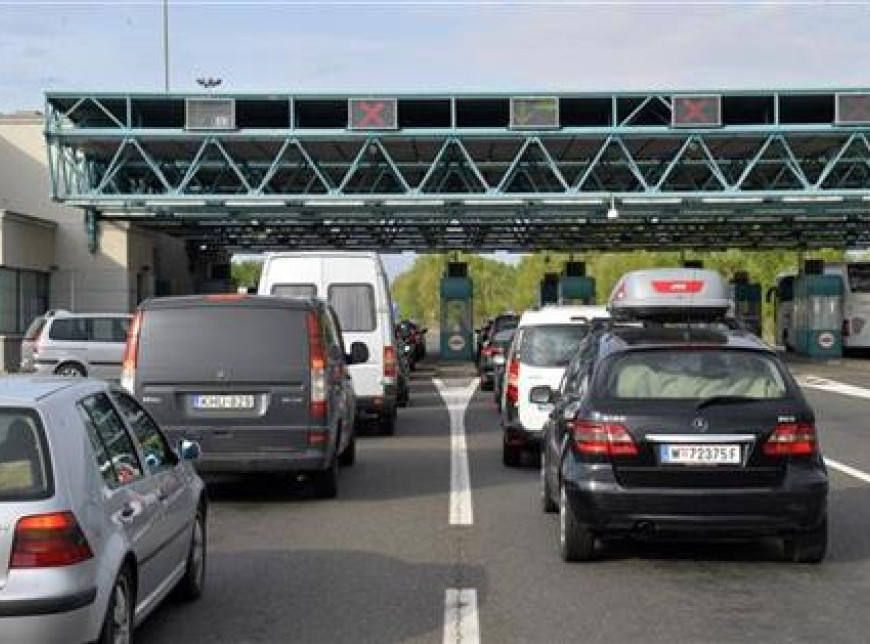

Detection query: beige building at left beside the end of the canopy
xmin=0 ymin=112 xmax=210 ymax=371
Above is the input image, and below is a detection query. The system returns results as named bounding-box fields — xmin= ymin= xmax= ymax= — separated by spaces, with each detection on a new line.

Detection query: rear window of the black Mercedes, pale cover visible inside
xmin=601 ymin=349 xmax=788 ymax=400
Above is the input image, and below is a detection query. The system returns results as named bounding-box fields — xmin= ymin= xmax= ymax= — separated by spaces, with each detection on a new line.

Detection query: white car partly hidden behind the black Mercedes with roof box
xmin=501 ymin=306 xmax=610 ymax=467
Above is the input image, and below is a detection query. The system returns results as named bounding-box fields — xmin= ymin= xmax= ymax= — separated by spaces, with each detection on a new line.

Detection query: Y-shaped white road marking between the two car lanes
xmin=432 ymin=378 xmax=480 ymax=525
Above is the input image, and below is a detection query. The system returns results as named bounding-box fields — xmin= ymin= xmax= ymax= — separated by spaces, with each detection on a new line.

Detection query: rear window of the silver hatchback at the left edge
xmin=0 ymin=409 xmax=52 ymax=501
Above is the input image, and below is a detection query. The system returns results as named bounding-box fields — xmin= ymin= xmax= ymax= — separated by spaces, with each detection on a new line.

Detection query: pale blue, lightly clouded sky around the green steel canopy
xmin=0 ymin=0 xmax=870 ymax=280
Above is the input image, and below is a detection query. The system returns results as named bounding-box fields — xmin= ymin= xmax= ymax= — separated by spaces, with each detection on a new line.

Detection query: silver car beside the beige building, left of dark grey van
xmin=21 ymin=311 xmax=131 ymax=380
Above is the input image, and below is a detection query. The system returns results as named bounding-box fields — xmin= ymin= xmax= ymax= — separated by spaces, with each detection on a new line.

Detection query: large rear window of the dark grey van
xmin=137 ymin=304 xmax=308 ymax=384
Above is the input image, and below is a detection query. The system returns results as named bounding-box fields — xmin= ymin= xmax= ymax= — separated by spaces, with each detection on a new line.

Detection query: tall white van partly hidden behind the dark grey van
xmin=258 ymin=251 xmax=397 ymax=434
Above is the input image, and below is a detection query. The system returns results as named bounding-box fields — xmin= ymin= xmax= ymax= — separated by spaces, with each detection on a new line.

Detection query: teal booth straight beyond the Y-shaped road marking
xmin=441 ymin=262 xmax=474 ymax=360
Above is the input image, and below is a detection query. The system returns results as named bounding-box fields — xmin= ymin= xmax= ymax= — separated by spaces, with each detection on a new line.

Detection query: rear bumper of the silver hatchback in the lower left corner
xmin=0 ymin=588 xmax=102 ymax=644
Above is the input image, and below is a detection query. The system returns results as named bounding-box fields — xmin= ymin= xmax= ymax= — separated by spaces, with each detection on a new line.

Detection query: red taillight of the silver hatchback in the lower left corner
xmin=9 ymin=512 xmax=94 ymax=568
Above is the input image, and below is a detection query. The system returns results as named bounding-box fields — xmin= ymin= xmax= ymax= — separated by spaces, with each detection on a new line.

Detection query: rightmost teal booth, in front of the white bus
xmin=793 ymin=260 xmax=843 ymax=359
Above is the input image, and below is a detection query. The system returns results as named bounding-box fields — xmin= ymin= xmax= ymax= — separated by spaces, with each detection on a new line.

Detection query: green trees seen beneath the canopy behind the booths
xmin=392 ymin=250 xmax=843 ymax=335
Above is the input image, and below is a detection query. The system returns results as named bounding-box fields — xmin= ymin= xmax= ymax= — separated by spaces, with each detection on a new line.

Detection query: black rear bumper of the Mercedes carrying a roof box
xmin=564 ymin=463 xmax=828 ymax=538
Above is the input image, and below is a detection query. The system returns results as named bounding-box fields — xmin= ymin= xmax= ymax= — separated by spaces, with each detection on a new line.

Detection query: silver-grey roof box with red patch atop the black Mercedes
xmin=608 ymin=268 xmax=731 ymax=321
